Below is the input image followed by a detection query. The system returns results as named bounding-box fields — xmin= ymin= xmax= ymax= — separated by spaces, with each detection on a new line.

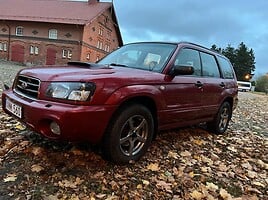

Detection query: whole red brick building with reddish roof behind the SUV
xmin=0 ymin=0 xmax=123 ymax=65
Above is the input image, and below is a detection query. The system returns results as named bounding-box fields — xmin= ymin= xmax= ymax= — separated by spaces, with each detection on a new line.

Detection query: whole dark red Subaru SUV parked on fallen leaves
xmin=2 ymin=42 xmax=237 ymax=163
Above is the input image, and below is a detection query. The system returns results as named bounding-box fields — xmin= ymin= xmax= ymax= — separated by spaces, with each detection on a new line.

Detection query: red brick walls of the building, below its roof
xmin=0 ymin=7 xmax=119 ymax=65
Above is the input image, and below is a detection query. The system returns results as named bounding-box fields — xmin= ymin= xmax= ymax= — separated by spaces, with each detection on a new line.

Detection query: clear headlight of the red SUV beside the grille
xmin=46 ymin=82 xmax=96 ymax=101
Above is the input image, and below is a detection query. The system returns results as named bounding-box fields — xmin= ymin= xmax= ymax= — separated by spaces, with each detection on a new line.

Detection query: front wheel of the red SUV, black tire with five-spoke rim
xmin=102 ymin=104 xmax=154 ymax=164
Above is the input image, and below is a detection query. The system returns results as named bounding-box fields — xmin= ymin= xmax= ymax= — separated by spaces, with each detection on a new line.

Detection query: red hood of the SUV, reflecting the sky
xmin=20 ymin=65 xmax=163 ymax=82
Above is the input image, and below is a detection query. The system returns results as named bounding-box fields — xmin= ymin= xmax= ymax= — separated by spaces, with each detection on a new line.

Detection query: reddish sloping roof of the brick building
xmin=0 ymin=0 xmax=112 ymax=25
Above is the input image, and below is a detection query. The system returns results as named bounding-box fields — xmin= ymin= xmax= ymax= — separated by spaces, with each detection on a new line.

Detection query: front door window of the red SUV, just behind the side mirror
xmin=175 ymin=49 xmax=201 ymax=76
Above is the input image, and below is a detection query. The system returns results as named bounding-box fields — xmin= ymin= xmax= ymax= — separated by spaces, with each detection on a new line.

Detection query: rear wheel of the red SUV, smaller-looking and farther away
xmin=207 ymin=101 xmax=232 ymax=135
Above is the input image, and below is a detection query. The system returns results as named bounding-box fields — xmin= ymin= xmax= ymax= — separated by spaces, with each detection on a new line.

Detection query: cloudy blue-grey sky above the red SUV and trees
xmin=99 ymin=0 xmax=268 ymax=76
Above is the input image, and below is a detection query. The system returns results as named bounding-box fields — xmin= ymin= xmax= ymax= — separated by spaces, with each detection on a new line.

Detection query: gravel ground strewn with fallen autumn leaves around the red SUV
xmin=0 ymin=61 xmax=268 ymax=200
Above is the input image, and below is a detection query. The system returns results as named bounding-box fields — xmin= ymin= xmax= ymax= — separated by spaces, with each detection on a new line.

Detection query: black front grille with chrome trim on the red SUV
xmin=15 ymin=75 xmax=40 ymax=99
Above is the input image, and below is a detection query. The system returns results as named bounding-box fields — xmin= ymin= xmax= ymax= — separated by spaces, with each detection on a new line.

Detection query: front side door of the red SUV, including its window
xmin=161 ymin=48 xmax=203 ymax=125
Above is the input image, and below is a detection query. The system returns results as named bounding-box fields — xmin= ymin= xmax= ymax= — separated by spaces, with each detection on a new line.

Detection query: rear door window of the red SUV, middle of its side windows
xmin=200 ymin=52 xmax=220 ymax=77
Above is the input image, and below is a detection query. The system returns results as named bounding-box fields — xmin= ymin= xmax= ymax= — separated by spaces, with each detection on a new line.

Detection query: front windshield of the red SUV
xmin=98 ymin=43 xmax=176 ymax=72
